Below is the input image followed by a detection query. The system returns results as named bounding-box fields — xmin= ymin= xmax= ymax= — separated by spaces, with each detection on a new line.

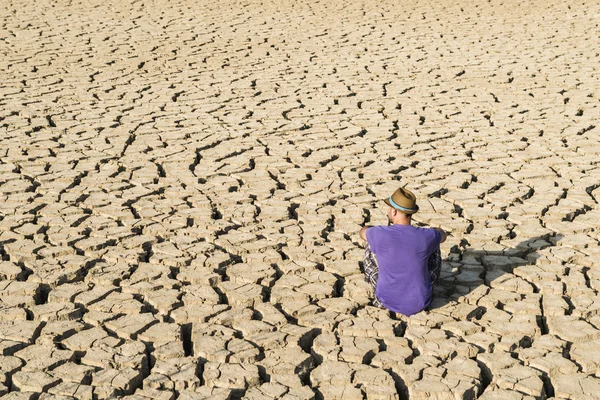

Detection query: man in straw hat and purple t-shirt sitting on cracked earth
xmin=360 ymin=188 xmax=446 ymax=315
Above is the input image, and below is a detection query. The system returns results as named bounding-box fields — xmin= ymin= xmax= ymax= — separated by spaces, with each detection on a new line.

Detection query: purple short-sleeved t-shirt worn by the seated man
xmin=366 ymin=225 xmax=442 ymax=315
